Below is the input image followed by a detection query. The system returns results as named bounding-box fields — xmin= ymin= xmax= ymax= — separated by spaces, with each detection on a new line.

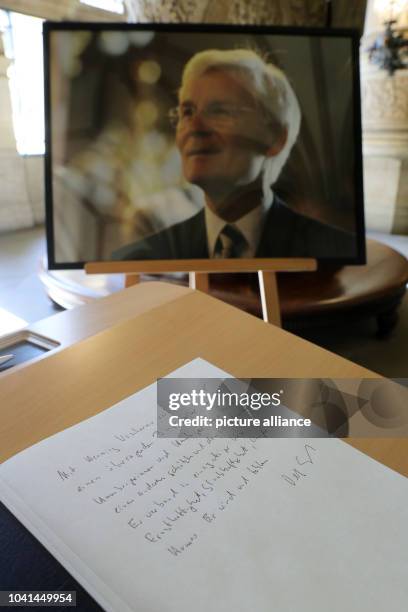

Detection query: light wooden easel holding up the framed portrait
xmin=85 ymin=258 xmax=317 ymax=327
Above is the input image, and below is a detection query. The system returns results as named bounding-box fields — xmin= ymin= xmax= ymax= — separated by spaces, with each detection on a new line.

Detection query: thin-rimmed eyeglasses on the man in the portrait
xmin=168 ymin=102 xmax=256 ymax=128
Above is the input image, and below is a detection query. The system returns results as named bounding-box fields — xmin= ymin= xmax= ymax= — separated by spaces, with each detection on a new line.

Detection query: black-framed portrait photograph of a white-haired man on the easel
xmin=44 ymin=22 xmax=365 ymax=272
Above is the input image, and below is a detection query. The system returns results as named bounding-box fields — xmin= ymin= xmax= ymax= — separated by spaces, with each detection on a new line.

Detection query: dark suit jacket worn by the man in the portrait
xmin=112 ymin=196 xmax=357 ymax=260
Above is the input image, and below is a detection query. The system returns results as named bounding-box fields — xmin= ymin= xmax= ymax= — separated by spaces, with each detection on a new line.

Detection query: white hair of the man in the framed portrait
xmin=179 ymin=49 xmax=301 ymax=190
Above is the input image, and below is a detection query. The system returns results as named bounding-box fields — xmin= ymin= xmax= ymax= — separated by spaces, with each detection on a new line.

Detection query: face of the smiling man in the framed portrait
xmin=176 ymin=70 xmax=271 ymax=207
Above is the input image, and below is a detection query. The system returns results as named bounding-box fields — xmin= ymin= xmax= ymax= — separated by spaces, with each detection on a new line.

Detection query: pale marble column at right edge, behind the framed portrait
xmin=361 ymin=0 xmax=408 ymax=234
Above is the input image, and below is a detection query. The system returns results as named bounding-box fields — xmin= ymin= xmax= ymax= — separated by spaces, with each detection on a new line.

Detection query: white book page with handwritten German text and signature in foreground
xmin=0 ymin=360 xmax=408 ymax=612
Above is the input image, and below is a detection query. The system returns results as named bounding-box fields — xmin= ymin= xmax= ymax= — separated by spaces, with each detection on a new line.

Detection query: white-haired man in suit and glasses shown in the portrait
xmin=113 ymin=49 xmax=356 ymax=260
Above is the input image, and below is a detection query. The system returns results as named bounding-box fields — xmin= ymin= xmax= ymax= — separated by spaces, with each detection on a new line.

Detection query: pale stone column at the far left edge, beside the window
xmin=0 ymin=32 xmax=34 ymax=231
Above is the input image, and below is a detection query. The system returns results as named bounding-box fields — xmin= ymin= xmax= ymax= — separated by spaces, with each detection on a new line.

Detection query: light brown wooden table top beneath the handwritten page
xmin=0 ymin=282 xmax=408 ymax=475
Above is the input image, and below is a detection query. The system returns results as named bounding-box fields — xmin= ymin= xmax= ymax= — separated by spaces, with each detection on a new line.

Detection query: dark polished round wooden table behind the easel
xmin=40 ymin=239 xmax=408 ymax=336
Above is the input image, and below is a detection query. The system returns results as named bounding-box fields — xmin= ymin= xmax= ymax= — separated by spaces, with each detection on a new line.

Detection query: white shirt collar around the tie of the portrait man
xmin=204 ymin=192 xmax=273 ymax=257
